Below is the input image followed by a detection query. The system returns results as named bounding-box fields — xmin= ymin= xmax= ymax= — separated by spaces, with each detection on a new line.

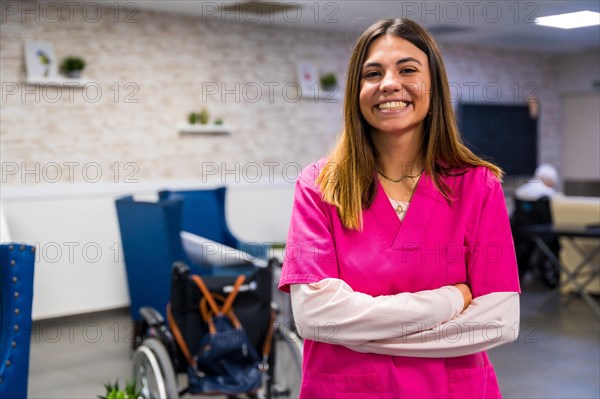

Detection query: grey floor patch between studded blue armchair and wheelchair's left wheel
xmin=28 ymin=309 xmax=132 ymax=399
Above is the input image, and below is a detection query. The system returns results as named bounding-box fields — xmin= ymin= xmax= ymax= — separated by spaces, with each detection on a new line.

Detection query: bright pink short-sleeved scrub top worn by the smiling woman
xmin=279 ymin=160 xmax=519 ymax=399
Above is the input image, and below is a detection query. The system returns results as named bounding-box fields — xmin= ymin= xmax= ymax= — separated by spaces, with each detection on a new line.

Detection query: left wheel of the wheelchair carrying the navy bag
xmin=133 ymin=338 xmax=179 ymax=399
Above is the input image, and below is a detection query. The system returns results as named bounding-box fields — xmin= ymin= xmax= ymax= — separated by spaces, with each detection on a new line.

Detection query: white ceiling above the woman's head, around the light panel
xmin=124 ymin=0 xmax=600 ymax=52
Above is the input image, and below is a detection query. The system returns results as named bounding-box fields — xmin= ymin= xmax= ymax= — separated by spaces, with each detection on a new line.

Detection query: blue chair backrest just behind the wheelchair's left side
xmin=116 ymin=196 xmax=191 ymax=320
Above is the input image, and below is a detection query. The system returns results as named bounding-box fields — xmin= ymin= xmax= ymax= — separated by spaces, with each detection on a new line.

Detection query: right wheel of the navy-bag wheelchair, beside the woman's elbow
xmin=269 ymin=326 xmax=302 ymax=399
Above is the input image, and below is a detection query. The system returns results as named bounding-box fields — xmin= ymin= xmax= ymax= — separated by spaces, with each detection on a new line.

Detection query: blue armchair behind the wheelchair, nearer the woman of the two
xmin=159 ymin=187 xmax=270 ymax=260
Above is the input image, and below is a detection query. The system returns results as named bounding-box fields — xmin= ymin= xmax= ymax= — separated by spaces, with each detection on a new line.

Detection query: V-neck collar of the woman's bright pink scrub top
xmin=373 ymin=172 xmax=445 ymax=250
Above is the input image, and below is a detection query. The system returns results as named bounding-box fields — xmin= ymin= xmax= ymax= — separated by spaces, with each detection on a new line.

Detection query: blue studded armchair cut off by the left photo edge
xmin=0 ymin=244 xmax=35 ymax=399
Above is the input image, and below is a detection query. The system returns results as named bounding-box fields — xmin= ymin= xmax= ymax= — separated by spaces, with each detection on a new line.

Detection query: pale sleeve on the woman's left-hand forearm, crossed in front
xmin=290 ymin=278 xmax=464 ymax=345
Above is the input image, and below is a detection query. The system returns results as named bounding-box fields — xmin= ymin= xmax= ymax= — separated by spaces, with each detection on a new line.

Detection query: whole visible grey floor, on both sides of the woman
xmin=29 ymin=283 xmax=600 ymax=399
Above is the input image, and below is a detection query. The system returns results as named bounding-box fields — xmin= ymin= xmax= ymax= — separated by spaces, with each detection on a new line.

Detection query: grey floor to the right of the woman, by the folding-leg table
xmin=489 ymin=278 xmax=600 ymax=399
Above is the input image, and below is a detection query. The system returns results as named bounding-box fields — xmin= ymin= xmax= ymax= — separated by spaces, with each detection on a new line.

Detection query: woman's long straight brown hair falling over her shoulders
xmin=317 ymin=19 xmax=503 ymax=230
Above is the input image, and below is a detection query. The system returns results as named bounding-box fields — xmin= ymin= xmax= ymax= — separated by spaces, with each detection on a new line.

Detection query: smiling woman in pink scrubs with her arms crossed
xmin=280 ymin=19 xmax=519 ymax=399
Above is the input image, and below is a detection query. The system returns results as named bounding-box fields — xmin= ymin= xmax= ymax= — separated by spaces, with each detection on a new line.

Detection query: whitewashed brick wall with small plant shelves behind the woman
xmin=0 ymin=3 xmax=561 ymax=185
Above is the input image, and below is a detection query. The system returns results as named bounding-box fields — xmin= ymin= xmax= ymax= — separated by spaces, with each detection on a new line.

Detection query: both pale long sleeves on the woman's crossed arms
xmin=291 ymin=278 xmax=519 ymax=357
